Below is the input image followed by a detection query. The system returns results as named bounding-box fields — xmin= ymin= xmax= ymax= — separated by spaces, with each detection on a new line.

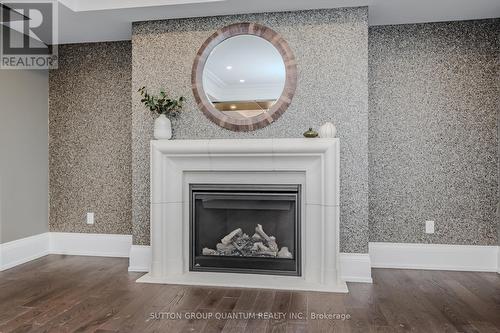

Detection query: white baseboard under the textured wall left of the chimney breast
xmin=49 ymin=232 xmax=132 ymax=258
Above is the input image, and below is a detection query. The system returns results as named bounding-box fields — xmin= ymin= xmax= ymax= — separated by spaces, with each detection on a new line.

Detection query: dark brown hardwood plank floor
xmin=0 ymin=255 xmax=500 ymax=333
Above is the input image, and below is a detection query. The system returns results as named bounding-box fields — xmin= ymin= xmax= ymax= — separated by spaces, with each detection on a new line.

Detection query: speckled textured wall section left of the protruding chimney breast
xmin=49 ymin=42 xmax=132 ymax=234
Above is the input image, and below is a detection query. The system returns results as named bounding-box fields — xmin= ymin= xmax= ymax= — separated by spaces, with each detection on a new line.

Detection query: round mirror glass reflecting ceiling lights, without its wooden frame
xmin=203 ymin=35 xmax=286 ymax=119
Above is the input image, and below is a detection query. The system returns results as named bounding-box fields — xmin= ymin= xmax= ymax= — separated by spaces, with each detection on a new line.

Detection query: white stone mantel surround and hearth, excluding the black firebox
xmin=138 ymin=139 xmax=347 ymax=292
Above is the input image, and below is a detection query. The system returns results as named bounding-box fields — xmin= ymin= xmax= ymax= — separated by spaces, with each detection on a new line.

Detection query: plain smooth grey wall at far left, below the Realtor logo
xmin=0 ymin=70 xmax=49 ymax=243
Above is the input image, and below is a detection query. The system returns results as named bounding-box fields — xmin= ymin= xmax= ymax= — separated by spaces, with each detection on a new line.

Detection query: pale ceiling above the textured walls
xmin=23 ymin=0 xmax=500 ymax=44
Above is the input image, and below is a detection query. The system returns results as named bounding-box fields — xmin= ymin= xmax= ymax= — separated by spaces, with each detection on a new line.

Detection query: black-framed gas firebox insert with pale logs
xmin=189 ymin=184 xmax=301 ymax=276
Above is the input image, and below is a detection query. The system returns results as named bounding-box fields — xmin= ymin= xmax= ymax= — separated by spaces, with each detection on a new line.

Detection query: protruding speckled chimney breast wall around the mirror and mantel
xmin=132 ymin=7 xmax=368 ymax=252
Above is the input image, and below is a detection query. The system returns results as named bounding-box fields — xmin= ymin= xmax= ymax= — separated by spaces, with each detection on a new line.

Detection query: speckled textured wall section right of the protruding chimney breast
xmin=369 ymin=19 xmax=500 ymax=245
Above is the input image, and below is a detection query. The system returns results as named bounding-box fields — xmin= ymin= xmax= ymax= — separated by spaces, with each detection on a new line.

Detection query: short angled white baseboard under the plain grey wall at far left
xmin=0 ymin=232 xmax=49 ymax=271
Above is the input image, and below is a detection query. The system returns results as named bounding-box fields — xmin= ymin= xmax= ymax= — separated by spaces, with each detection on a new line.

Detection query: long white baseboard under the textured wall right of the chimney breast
xmin=369 ymin=243 xmax=499 ymax=272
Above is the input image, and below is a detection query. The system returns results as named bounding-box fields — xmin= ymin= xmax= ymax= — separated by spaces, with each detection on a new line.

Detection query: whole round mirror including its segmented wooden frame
xmin=191 ymin=23 xmax=297 ymax=132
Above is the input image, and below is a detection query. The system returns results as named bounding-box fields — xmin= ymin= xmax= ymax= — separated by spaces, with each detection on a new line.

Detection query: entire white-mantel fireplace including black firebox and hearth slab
xmin=138 ymin=139 xmax=347 ymax=292
